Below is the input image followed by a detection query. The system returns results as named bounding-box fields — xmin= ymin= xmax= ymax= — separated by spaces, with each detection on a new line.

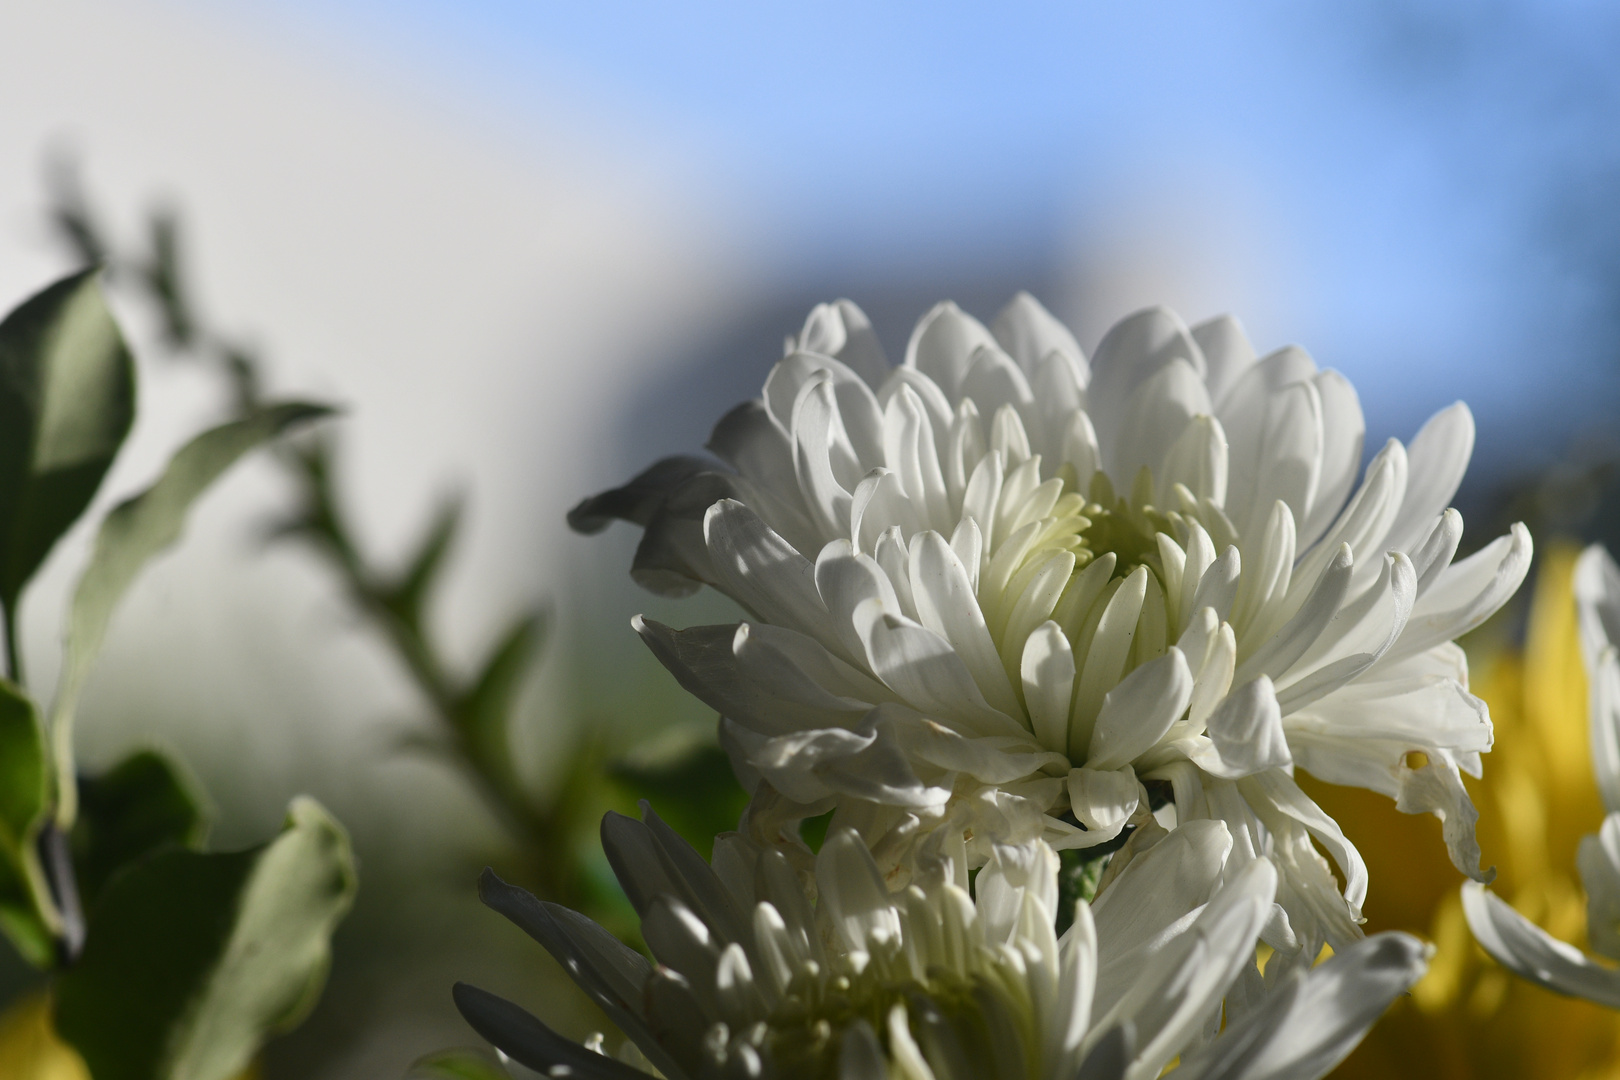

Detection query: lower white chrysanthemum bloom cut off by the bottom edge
xmin=455 ymin=814 xmax=1426 ymax=1080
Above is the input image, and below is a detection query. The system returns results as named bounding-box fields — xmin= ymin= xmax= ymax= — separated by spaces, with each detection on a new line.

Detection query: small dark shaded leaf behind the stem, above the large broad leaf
xmin=73 ymin=750 xmax=207 ymax=907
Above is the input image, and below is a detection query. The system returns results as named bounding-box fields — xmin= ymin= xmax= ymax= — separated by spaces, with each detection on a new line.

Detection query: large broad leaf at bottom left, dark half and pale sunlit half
xmin=57 ymin=798 xmax=355 ymax=1080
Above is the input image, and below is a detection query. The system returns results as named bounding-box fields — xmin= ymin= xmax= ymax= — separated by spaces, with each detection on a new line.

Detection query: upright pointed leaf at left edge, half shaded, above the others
xmin=0 ymin=270 xmax=134 ymax=609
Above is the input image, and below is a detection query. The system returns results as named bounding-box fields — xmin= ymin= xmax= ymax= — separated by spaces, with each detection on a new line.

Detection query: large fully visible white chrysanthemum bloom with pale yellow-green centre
xmin=570 ymin=295 xmax=1531 ymax=959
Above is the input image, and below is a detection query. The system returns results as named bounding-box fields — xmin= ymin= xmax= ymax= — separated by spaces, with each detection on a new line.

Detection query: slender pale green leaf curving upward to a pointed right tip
xmin=50 ymin=402 xmax=330 ymax=831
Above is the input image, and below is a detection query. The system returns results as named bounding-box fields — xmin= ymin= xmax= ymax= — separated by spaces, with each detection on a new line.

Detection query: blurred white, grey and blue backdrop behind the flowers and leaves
xmin=0 ymin=0 xmax=1620 ymax=1078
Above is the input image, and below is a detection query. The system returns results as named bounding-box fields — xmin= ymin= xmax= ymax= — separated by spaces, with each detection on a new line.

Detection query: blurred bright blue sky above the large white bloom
xmin=249 ymin=0 xmax=1620 ymax=472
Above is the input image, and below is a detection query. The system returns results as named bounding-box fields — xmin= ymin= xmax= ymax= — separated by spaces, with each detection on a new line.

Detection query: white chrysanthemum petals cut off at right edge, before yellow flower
xmin=1463 ymin=544 xmax=1620 ymax=1009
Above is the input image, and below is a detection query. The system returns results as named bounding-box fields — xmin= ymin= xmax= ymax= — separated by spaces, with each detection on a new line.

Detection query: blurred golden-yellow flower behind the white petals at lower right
xmin=1302 ymin=546 xmax=1620 ymax=1080
